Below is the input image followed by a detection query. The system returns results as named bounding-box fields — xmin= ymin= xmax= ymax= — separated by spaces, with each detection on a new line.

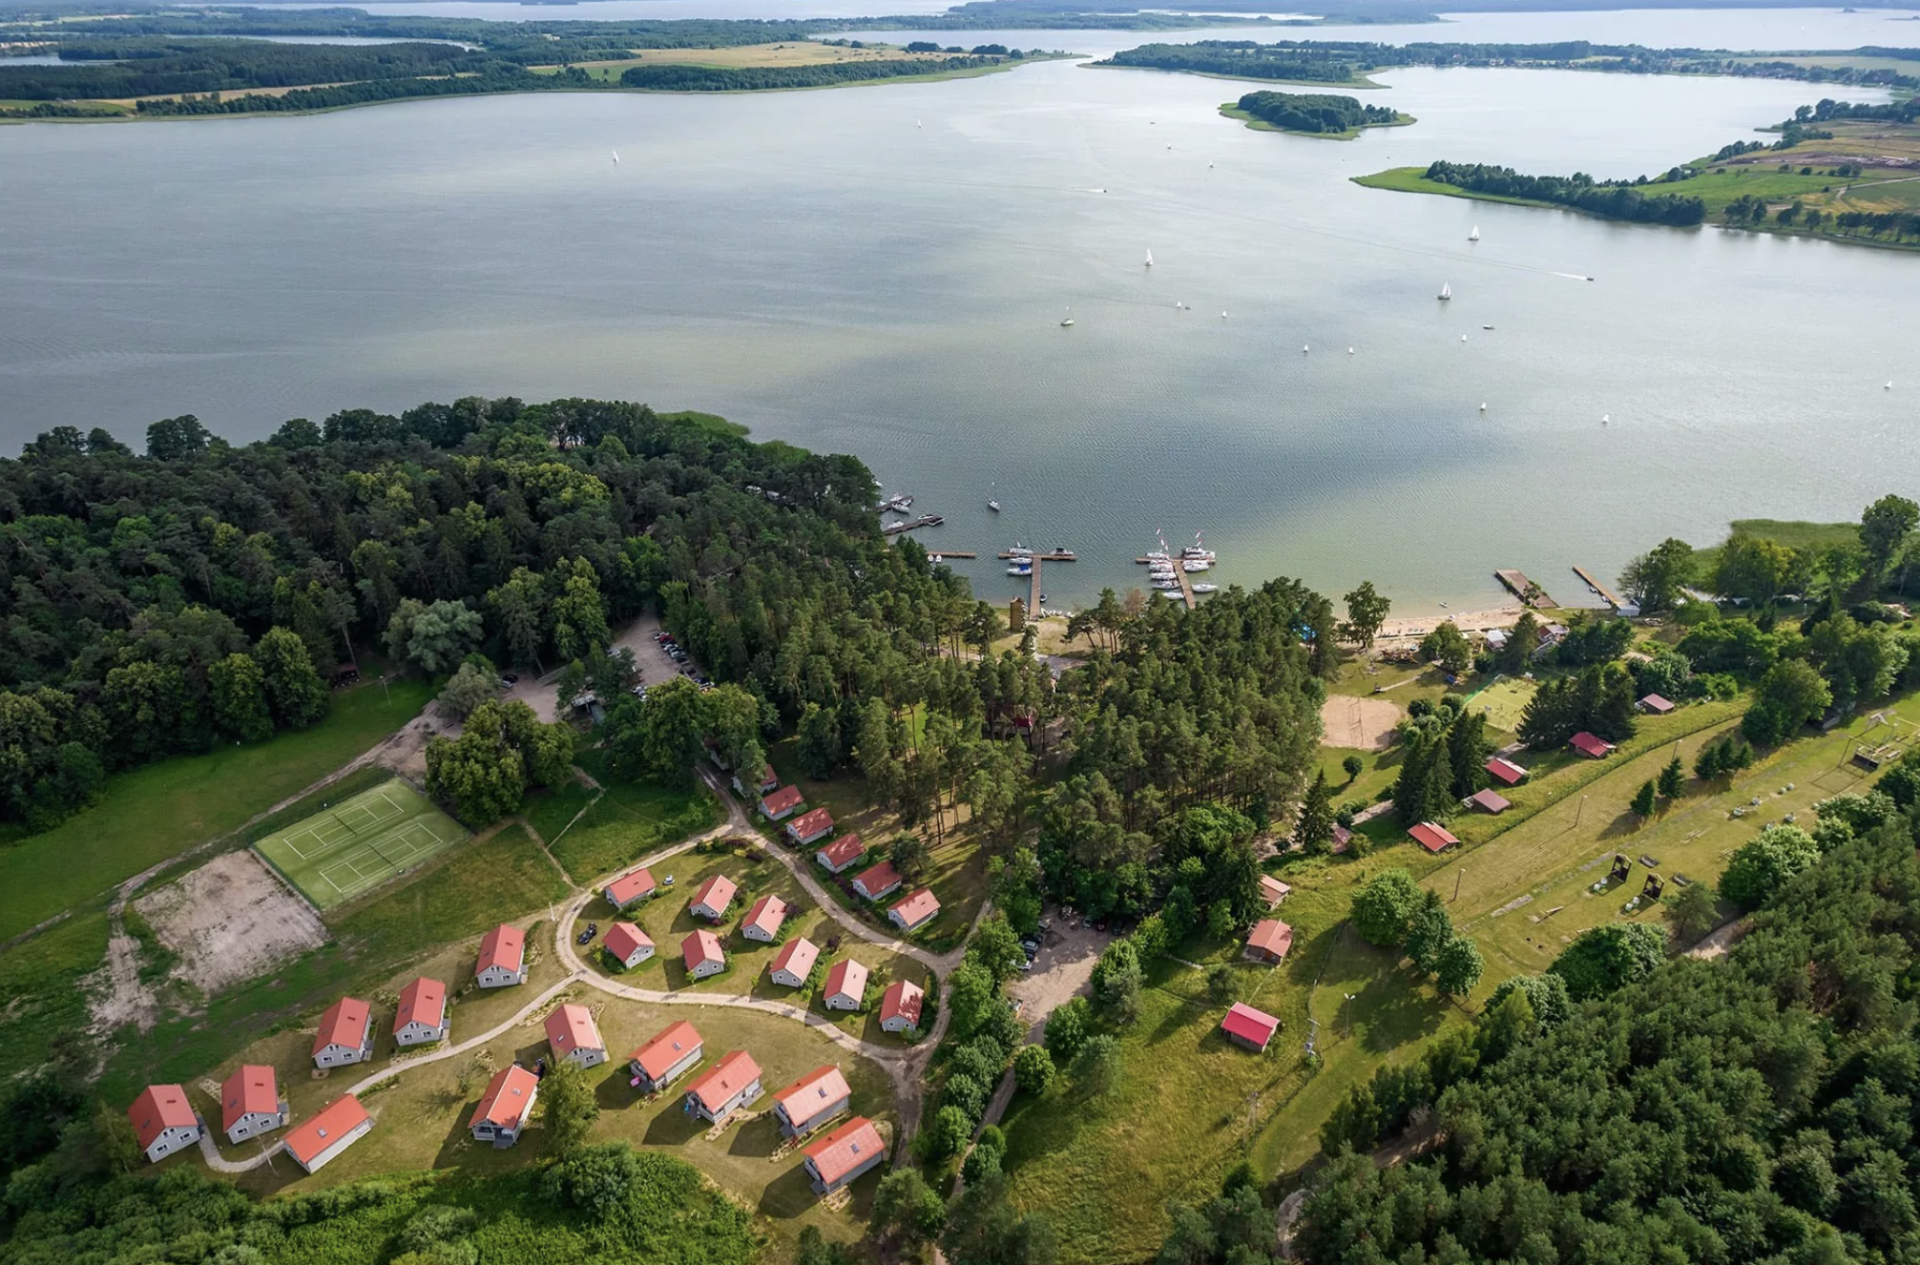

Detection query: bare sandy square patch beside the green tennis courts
xmin=132 ymin=852 xmax=328 ymax=992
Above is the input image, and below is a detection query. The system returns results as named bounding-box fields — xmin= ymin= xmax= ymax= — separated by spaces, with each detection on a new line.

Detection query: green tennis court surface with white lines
xmin=253 ymin=781 xmax=467 ymax=910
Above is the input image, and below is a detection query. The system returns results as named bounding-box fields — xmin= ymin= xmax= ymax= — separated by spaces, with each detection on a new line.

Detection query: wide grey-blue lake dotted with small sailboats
xmin=0 ymin=0 xmax=1920 ymax=610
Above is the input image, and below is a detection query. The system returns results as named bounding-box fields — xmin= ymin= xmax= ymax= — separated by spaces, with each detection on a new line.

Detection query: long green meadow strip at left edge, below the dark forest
xmin=0 ymin=681 xmax=434 ymax=939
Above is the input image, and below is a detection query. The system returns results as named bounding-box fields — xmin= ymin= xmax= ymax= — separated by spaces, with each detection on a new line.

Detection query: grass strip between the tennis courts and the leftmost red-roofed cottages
xmin=104 ymin=827 xmax=568 ymax=1094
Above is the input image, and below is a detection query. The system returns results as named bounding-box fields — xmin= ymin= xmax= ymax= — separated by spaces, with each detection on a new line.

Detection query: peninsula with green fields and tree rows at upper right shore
xmin=1354 ymin=98 xmax=1920 ymax=250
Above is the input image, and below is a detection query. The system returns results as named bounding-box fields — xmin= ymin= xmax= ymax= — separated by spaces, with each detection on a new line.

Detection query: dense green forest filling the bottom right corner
xmin=1298 ymin=810 xmax=1920 ymax=1265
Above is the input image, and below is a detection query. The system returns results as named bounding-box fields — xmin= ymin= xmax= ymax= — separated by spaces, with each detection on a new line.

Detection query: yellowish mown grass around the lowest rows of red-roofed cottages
xmin=216 ymin=983 xmax=893 ymax=1255
